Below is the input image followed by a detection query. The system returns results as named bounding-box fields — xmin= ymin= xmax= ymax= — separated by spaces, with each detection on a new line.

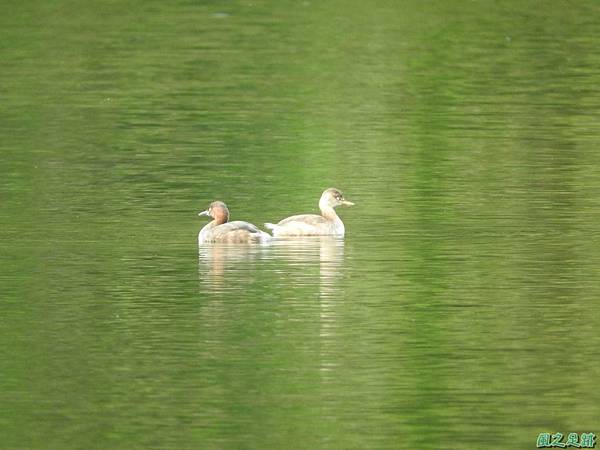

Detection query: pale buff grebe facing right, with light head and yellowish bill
xmin=265 ymin=188 xmax=354 ymax=237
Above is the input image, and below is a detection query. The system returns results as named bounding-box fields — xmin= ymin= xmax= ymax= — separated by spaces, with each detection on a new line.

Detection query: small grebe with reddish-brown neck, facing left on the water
xmin=198 ymin=201 xmax=271 ymax=245
